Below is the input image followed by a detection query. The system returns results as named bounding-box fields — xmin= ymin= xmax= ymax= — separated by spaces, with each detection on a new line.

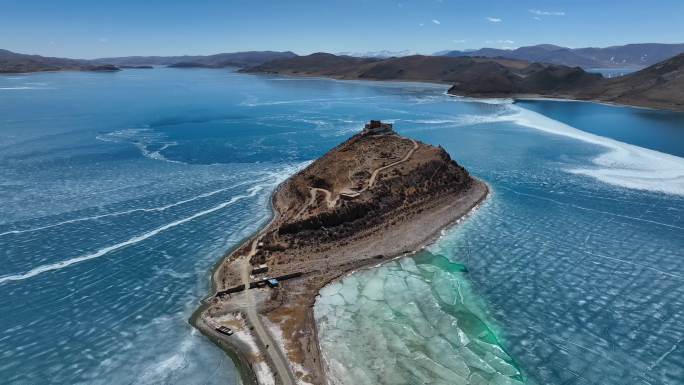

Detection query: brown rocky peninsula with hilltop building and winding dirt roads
xmin=192 ymin=121 xmax=488 ymax=384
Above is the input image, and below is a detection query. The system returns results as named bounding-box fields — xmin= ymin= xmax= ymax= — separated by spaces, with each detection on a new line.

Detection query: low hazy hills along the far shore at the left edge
xmin=0 ymin=49 xmax=297 ymax=73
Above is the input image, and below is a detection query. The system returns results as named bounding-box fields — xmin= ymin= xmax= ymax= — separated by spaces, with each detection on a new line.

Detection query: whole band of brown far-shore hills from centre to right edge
xmin=242 ymin=53 xmax=684 ymax=110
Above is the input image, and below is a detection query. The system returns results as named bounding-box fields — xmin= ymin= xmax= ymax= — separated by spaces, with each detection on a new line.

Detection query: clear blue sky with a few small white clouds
xmin=0 ymin=0 xmax=684 ymax=58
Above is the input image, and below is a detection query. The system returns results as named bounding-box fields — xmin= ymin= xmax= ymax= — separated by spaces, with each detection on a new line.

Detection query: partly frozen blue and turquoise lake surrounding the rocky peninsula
xmin=0 ymin=69 xmax=684 ymax=385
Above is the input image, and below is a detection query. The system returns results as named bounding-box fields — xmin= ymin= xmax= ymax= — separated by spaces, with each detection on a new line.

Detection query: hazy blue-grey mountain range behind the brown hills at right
xmin=435 ymin=43 xmax=684 ymax=69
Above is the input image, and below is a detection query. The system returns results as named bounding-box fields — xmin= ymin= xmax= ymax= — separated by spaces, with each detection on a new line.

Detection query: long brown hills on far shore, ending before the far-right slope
xmin=243 ymin=53 xmax=602 ymax=97
